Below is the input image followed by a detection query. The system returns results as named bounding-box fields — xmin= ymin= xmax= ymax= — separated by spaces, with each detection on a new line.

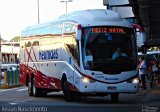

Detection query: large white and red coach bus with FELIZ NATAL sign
xmin=20 ymin=9 xmax=139 ymax=101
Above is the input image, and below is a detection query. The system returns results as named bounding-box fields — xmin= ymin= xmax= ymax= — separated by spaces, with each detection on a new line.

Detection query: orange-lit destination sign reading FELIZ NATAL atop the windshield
xmin=91 ymin=27 xmax=125 ymax=33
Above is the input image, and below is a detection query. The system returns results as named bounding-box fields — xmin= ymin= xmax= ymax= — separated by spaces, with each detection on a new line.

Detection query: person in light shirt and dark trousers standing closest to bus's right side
xmin=139 ymin=56 xmax=148 ymax=89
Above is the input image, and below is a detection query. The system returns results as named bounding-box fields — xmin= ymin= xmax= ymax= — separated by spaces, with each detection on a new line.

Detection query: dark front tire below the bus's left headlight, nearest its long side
xmin=63 ymin=79 xmax=74 ymax=102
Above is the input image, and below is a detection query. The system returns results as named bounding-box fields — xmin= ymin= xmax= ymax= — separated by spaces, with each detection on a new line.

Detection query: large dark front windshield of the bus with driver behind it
xmin=82 ymin=26 xmax=137 ymax=74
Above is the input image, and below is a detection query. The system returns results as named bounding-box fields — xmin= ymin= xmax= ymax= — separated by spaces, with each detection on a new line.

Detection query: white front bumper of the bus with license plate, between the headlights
xmin=79 ymin=82 xmax=139 ymax=93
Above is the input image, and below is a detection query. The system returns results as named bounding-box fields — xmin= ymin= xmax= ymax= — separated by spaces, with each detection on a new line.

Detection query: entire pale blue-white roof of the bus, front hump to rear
xmin=22 ymin=9 xmax=131 ymax=35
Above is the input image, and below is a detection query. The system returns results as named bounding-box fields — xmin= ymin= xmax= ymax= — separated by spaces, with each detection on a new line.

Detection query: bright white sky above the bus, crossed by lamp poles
xmin=0 ymin=0 xmax=106 ymax=40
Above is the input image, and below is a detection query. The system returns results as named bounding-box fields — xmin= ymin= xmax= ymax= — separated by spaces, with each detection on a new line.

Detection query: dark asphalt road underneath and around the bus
xmin=0 ymin=87 xmax=160 ymax=112
